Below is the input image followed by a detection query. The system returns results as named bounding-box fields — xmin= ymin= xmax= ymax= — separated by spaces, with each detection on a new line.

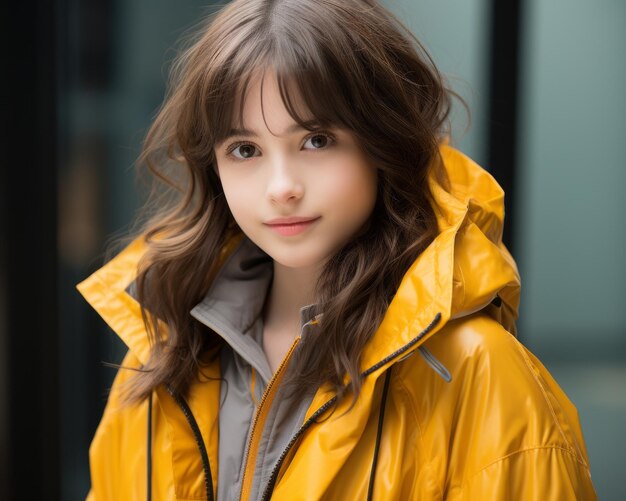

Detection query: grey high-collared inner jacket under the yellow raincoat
xmin=191 ymin=238 xmax=318 ymax=501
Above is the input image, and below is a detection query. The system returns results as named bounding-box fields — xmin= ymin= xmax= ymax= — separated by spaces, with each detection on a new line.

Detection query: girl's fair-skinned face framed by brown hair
xmin=215 ymin=71 xmax=377 ymax=268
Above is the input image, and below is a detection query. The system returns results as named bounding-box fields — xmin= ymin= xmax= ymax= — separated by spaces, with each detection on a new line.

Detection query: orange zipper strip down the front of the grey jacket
xmin=239 ymin=337 xmax=300 ymax=501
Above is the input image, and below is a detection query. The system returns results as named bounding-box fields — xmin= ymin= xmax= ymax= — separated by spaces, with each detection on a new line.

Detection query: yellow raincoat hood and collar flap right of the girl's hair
xmin=354 ymin=145 xmax=520 ymax=370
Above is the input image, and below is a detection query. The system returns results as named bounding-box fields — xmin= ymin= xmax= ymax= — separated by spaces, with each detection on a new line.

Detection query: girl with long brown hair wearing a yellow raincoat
xmin=79 ymin=0 xmax=595 ymax=501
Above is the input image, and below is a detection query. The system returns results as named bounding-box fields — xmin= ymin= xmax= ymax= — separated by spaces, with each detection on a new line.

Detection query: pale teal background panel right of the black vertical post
xmin=517 ymin=0 xmax=626 ymax=356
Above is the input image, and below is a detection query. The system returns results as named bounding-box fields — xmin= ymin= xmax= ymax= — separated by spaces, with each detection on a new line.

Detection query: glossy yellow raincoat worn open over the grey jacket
xmin=79 ymin=146 xmax=596 ymax=501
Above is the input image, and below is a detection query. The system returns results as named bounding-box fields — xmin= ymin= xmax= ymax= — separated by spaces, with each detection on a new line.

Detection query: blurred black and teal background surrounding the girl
xmin=0 ymin=0 xmax=626 ymax=500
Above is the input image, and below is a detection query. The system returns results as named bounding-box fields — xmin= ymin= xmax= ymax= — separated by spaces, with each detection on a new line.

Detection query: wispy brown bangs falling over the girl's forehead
xmin=204 ymin=13 xmax=362 ymax=145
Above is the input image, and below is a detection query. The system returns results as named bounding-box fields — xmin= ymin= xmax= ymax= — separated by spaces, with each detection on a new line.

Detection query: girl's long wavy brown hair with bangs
xmin=128 ymin=0 xmax=453 ymax=401
